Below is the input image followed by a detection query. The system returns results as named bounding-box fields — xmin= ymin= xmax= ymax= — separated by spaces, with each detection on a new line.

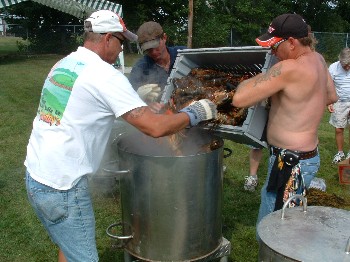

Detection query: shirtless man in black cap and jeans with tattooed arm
xmin=232 ymin=14 xmax=338 ymax=223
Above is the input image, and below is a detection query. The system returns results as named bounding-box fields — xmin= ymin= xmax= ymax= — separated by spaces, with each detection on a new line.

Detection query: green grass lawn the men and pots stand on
xmin=0 ymin=39 xmax=350 ymax=262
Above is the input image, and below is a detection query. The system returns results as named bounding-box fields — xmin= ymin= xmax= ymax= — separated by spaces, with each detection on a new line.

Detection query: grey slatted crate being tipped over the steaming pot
xmin=161 ymin=46 xmax=275 ymax=147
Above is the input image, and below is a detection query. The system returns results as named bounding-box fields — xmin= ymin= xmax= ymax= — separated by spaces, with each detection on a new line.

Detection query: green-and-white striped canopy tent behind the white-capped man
xmin=0 ymin=0 xmax=125 ymax=73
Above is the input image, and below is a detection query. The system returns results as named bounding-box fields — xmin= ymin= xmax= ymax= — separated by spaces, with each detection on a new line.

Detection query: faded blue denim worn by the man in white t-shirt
xmin=26 ymin=171 xmax=98 ymax=262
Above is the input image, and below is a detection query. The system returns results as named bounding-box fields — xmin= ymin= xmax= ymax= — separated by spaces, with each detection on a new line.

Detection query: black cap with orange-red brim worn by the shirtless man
xmin=255 ymin=14 xmax=308 ymax=47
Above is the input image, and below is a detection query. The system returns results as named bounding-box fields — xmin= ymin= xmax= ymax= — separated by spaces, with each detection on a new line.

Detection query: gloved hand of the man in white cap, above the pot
xmin=179 ymin=99 xmax=218 ymax=126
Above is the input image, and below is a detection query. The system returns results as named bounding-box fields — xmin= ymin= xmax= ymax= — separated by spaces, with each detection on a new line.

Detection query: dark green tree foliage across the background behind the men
xmin=2 ymin=0 xmax=350 ymax=51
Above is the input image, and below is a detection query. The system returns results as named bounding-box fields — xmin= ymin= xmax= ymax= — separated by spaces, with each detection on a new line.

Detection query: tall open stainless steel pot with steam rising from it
xmin=107 ymin=128 xmax=227 ymax=261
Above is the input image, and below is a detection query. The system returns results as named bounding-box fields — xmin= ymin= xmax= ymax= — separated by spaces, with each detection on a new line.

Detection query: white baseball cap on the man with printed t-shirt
xmin=84 ymin=10 xmax=137 ymax=42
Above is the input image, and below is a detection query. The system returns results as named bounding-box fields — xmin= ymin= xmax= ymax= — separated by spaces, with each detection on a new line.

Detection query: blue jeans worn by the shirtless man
xmin=257 ymin=150 xmax=320 ymax=225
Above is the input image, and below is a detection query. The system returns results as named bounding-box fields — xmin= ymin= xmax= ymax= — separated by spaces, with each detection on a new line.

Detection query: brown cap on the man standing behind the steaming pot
xmin=136 ymin=21 xmax=163 ymax=51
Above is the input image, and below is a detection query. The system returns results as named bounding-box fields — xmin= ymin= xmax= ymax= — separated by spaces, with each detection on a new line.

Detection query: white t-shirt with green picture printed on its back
xmin=24 ymin=47 xmax=146 ymax=190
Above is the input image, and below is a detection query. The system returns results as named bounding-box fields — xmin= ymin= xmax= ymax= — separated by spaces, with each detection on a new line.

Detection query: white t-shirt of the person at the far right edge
xmin=329 ymin=61 xmax=350 ymax=102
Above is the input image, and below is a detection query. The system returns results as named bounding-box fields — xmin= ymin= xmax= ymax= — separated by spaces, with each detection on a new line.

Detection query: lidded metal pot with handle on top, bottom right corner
xmin=258 ymin=195 xmax=350 ymax=262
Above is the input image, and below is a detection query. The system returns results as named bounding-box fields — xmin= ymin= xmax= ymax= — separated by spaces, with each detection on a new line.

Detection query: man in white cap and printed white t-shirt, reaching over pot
xmin=24 ymin=10 xmax=217 ymax=262
